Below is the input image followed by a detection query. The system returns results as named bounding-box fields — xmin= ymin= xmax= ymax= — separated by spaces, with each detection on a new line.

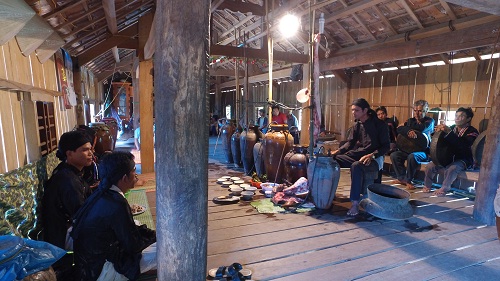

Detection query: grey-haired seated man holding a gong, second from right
xmin=391 ymin=100 xmax=434 ymax=189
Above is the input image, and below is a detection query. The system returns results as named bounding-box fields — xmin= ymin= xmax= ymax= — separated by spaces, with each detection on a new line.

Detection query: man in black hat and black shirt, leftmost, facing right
xmin=42 ymin=131 xmax=93 ymax=280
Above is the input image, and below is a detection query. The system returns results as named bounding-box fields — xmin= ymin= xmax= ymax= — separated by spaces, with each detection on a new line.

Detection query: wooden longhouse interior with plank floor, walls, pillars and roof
xmin=0 ymin=0 xmax=500 ymax=280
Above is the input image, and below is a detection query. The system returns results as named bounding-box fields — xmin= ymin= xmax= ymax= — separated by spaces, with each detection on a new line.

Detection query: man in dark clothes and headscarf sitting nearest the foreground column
xmin=71 ymin=152 xmax=156 ymax=281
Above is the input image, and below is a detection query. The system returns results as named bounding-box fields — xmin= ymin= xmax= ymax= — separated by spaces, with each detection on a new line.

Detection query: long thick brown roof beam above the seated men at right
xmin=320 ymin=21 xmax=500 ymax=71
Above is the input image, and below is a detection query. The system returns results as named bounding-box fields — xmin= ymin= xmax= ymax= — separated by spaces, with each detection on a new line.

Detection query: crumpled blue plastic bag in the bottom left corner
xmin=0 ymin=235 xmax=66 ymax=281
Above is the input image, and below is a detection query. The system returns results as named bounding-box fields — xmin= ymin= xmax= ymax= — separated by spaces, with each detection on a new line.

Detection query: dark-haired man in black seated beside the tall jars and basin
xmin=333 ymin=99 xmax=390 ymax=216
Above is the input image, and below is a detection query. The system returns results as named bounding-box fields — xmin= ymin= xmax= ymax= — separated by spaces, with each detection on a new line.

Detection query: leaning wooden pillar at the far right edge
xmin=473 ymin=62 xmax=500 ymax=225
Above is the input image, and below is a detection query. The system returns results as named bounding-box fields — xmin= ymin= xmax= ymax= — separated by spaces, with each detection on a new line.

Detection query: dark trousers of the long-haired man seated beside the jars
xmin=334 ymin=155 xmax=379 ymax=201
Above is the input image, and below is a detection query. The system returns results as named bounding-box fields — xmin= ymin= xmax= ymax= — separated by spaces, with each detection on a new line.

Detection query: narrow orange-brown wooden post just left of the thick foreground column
xmin=139 ymin=60 xmax=155 ymax=173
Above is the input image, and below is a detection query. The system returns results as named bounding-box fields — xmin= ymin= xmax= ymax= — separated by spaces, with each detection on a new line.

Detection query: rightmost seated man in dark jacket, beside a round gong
xmin=423 ymin=107 xmax=479 ymax=196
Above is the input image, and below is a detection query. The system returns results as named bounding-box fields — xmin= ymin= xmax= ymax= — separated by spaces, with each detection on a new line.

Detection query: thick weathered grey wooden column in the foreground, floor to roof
xmin=154 ymin=0 xmax=210 ymax=281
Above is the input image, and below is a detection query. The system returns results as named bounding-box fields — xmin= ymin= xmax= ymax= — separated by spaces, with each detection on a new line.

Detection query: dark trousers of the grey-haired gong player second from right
xmin=391 ymin=150 xmax=428 ymax=182
